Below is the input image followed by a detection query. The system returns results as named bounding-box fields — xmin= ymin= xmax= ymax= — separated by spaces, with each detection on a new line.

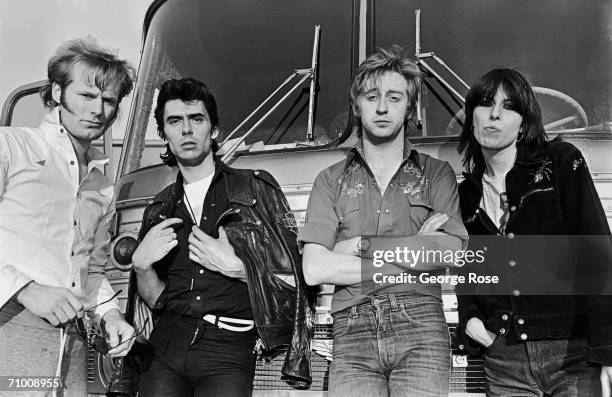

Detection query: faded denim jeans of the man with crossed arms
xmin=329 ymin=294 xmax=450 ymax=397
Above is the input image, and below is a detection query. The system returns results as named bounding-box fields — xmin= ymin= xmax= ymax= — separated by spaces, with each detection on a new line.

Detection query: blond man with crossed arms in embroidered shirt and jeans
xmin=298 ymin=46 xmax=467 ymax=397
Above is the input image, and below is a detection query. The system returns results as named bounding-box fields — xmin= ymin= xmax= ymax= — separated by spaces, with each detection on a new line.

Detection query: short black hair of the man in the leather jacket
xmin=154 ymin=77 xmax=219 ymax=166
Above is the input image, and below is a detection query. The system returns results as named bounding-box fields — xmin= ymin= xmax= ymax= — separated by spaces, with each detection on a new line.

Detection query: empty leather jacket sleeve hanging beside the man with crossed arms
xmin=256 ymin=171 xmax=314 ymax=387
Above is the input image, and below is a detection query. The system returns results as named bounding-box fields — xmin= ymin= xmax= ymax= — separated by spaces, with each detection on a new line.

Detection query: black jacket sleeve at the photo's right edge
xmin=558 ymin=143 xmax=612 ymax=365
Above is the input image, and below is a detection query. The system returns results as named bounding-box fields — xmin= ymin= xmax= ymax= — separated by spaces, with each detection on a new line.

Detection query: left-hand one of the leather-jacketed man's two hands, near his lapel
xmin=132 ymin=218 xmax=183 ymax=271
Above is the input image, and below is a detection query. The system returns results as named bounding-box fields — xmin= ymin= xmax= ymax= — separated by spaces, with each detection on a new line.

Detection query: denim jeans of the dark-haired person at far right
xmin=484 ymin=335 xmax=601 ymax=397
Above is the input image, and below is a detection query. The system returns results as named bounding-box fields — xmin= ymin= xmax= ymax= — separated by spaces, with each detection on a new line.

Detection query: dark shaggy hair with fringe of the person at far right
xmin=457 ymin=69 xmax=547 ymax=171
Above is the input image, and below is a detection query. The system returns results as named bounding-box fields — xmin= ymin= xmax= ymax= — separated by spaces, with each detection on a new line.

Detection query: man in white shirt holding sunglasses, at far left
xmin=0 ymin=39 xmax=135 ymax=395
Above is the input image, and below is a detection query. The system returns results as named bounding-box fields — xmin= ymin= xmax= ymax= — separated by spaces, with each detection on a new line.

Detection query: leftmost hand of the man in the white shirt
xmin=16 ymin=282 xmax=85 ymax=327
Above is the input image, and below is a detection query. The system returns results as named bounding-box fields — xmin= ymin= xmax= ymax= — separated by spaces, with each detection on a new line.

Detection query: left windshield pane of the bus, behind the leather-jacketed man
xmin=122 ymin=0 xmax=353 ymax=174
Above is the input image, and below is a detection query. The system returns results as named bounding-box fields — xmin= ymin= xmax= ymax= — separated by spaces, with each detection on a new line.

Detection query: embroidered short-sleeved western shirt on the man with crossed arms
xmin=298 ymin=139 xmax=467 ymax=313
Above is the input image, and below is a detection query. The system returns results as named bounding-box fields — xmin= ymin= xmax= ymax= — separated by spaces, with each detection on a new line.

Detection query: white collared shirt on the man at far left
xmin=0 ymin=108 xmax=119 ymax=316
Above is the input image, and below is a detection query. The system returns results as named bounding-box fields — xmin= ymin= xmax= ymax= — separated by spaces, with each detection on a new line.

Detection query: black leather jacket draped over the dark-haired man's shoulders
xmin=128 ymin=160 xmax=314 ymax=387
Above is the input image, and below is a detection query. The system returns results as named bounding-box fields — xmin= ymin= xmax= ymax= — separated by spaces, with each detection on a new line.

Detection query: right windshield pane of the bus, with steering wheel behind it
xmin=373 ymin=0 xmax=612 ymax=136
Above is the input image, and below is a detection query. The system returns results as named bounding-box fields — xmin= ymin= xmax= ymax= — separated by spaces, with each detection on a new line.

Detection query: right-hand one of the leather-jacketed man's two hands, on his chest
xmin=189 ymin=226 xmax=246 ymax=281
